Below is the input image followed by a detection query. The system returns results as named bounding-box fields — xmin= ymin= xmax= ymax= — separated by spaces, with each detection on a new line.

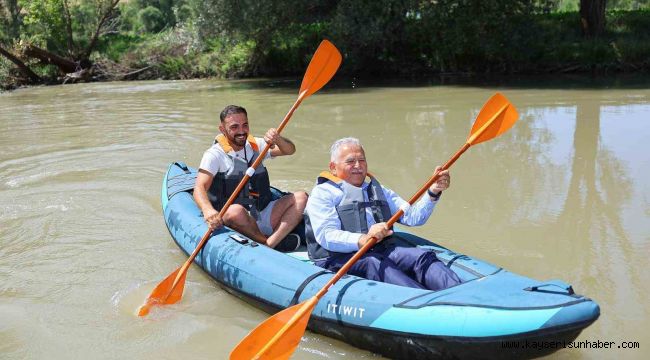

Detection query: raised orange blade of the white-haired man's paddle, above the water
xmin=467 ymin=93 xmax=519 ymax=145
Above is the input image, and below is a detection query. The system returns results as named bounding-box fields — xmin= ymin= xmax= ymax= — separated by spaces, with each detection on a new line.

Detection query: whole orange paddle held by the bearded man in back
xmin=138 ymin=40 xmax=341 ymax=316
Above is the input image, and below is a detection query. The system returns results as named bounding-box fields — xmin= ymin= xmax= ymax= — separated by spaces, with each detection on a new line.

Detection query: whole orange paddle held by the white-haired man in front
xmin=230 ymin=93 xmax=519 ymax=360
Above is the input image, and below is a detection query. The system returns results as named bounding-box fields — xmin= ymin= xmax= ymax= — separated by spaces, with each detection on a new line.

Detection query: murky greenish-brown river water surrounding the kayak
xmin=0 ymin=80 xmax=650 ymax=359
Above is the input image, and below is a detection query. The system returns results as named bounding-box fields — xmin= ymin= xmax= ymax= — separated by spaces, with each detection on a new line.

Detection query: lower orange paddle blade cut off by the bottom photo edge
xmin=230 ymin=296 xmax=318 ymax=360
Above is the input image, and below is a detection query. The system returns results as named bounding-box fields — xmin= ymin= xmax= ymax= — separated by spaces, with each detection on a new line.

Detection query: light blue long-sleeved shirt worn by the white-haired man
xmin=306 ymin=181 xmax=437 ymax=253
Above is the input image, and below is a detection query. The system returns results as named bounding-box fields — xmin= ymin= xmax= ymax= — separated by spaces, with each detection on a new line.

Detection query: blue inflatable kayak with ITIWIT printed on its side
xmin=161 ymin=162 xmax=600 ymax=360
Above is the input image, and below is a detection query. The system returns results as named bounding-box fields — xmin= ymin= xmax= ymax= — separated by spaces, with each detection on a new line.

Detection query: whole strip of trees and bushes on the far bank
xmin=0 ymin=0 xmax=650 ymax=88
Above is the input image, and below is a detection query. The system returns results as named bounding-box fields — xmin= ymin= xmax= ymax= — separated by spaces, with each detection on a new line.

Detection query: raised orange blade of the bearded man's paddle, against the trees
xmin=299 ymin=40 xmax=342 ymax=96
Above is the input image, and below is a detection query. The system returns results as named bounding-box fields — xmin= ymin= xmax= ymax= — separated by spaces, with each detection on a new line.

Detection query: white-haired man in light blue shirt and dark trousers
xmin=305 ymin=138 xmax=461 ymax=290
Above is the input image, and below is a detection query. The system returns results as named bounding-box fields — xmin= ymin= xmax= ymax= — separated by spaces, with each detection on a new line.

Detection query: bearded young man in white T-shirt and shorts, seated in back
xmin=194 ymin=105 xmax=307 ymax=251
